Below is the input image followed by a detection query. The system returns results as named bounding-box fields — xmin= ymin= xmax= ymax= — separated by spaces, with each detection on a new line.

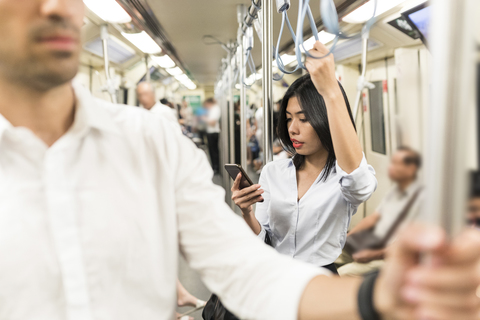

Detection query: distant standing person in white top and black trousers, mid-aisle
xmin=204 ymin=98 xmax=220 ymax=173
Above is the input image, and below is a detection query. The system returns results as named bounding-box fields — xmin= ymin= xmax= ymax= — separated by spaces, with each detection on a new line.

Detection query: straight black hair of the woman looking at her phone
xmin=277 ymin=74 xmax=355 ymax=181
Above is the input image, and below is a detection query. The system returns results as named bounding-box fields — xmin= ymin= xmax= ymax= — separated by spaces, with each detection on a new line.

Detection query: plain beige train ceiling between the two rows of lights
xmin=147 ymin=0 xmax=345 ymax=85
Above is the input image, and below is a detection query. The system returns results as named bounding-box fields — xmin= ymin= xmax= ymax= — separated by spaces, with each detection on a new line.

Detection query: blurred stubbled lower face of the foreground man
xmin=0 ymin=0 xmax=84 ymax=91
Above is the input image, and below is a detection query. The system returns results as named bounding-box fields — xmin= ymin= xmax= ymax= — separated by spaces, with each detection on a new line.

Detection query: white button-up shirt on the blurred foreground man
xmin=0 ymin=86 xmax=327 ymax=320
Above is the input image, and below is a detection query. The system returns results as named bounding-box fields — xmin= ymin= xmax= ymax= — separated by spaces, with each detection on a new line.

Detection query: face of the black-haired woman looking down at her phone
xmin=286 ymin=97 xmax=323 ymax=156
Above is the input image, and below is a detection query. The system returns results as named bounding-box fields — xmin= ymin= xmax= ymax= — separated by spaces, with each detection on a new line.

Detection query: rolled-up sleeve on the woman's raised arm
xmin=336 ymin=155 xmax=377 ymax=206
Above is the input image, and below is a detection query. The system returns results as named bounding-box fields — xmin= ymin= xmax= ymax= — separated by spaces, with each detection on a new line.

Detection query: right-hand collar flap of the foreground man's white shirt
xmin=72 ymin=82 xmax=120 ymax=134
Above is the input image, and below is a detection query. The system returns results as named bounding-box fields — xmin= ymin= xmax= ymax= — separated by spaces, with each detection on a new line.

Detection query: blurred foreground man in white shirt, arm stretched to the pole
xmin=0 ymin=0 xmax=480 ymax=320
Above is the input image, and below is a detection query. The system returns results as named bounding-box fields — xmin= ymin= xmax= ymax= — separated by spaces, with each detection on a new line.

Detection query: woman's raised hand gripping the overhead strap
xmin=305 ymin=41 xmax=341 ymax=98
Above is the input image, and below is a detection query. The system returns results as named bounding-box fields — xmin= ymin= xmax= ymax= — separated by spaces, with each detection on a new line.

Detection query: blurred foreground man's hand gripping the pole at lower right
xmin=374 ymin=226 xmax=480 ymax=320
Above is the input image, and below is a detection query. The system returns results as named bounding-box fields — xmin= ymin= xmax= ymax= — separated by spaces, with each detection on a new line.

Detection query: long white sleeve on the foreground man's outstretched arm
xmin=165 ymin=125 xmax=329 ymax=320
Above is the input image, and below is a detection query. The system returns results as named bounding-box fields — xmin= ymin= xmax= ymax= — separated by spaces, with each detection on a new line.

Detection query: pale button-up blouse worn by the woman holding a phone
xmin=255 ymin=156 xmax=377 ymax=267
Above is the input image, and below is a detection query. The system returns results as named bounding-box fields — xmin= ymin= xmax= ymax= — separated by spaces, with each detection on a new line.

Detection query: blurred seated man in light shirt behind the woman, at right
xmin=337 ymin=147 xmax=422 ymax=276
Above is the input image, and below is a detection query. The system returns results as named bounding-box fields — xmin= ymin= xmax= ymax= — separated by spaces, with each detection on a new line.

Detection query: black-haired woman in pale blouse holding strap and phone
xmin=232 ymin=42 xmax=377 ymax=273
